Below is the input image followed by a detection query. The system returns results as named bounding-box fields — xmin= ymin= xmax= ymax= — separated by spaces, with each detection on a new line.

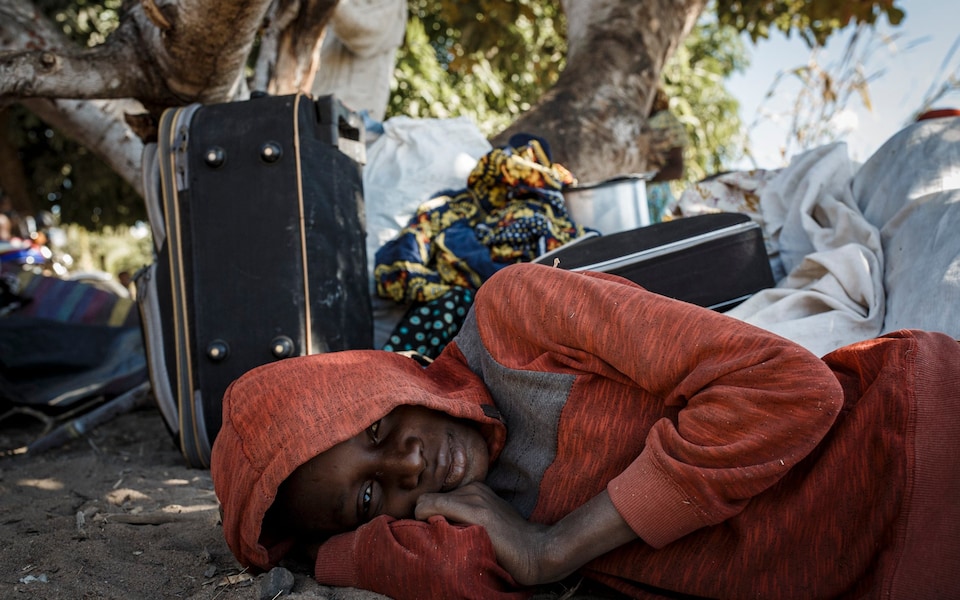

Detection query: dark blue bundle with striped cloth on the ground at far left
xmin=0 ymin=270 xmax=147 ymax=449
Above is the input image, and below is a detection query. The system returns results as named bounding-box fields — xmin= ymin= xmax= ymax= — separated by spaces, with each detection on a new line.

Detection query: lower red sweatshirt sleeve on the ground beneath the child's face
xmin=314 ymin=516 xmax=530 ymax=600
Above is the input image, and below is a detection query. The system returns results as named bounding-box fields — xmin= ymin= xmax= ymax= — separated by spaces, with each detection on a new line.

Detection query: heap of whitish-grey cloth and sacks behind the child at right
xmin=668 ymin=115 xmax=960 ymax=356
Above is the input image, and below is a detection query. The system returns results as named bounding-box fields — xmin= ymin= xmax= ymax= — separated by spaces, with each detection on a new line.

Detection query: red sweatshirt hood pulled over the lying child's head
xmin=210 ymin=345 xmax=506 ymax=570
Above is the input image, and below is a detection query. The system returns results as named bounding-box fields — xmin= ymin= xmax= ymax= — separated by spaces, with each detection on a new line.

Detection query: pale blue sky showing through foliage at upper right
xmin=727 ymin=0 xmax=960 ymax=168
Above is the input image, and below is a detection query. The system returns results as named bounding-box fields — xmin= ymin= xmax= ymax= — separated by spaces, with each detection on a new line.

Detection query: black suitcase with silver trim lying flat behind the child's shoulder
xmin=536 ymin=213 xmax=774 ymax=312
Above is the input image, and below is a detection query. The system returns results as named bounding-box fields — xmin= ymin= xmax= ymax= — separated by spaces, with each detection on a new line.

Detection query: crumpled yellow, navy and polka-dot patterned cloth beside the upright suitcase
xmin=374 ymin=135 xmax=588 ymax=357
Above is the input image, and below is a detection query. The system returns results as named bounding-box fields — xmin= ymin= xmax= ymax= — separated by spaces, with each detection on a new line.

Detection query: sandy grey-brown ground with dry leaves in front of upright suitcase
xmin=0 ymin=398 xmax=616 ymax=600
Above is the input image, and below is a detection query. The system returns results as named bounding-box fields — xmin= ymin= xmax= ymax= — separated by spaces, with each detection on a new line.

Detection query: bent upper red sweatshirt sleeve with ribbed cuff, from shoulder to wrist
xmin=474 ymin=264 xmax=843 ymax=548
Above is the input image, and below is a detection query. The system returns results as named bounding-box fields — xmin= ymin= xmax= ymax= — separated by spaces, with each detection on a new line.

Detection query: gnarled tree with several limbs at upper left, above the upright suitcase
xmin=0 ymin=0 xmax=337 ymax=200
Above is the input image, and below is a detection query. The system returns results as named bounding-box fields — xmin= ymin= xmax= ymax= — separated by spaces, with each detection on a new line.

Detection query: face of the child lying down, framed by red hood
xmin=277 ymin=406 xmax=489 ymax=534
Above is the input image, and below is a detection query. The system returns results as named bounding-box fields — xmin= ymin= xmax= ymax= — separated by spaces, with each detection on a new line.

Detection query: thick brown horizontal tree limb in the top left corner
xmin=0 ymin=0 xmax=270 ymax=108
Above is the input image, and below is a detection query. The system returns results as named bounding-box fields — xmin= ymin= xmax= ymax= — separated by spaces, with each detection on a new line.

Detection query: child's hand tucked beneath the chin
xmin=416 ymin=482 xmax=567 ymax=585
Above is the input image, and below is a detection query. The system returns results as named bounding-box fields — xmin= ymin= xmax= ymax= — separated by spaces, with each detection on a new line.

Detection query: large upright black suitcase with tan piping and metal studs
xmin=137 ymin=95 xmax=373 ymax=467
